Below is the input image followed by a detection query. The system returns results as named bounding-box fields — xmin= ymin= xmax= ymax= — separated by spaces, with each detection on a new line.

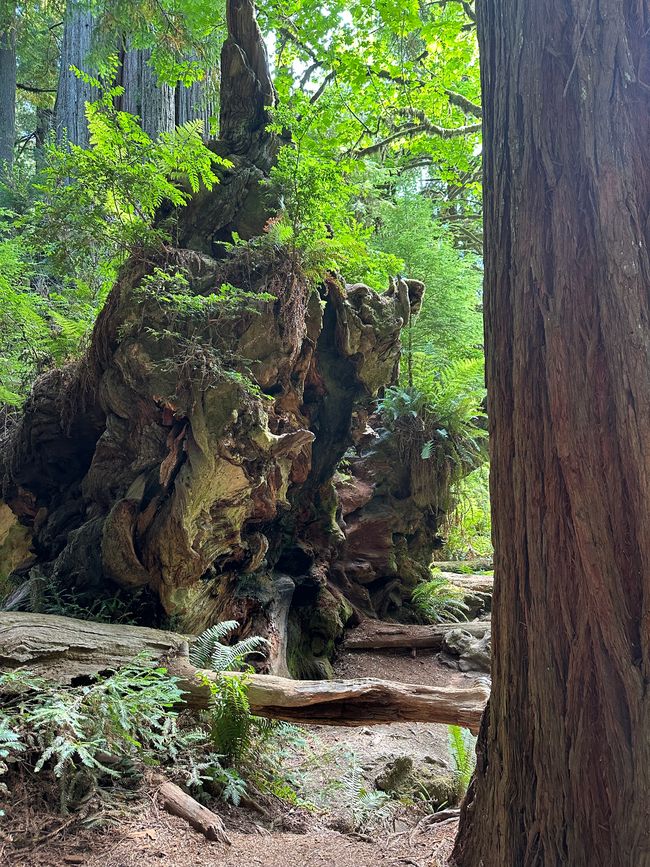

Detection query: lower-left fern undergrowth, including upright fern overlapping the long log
xmin=0 ymin=621 xmax=306 ymax=813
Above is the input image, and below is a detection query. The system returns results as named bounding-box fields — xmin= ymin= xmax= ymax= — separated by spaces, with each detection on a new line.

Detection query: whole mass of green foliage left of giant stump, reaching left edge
xmin=0 ymin=81 xmax=230 ymax=406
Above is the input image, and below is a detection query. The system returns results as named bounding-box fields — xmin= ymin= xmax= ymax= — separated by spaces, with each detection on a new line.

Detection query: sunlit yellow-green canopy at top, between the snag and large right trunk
xmin=259 ymin=0 xmax=479 ymax=182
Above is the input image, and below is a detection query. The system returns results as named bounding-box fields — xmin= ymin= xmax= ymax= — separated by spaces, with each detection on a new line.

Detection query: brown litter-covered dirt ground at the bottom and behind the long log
xmin=0 ymin=651 xmax=486 ymax=867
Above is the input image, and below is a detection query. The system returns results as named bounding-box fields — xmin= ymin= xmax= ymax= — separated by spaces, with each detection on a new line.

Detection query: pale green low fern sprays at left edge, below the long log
xmin=0 ymin=656 xmax=182 ymax=810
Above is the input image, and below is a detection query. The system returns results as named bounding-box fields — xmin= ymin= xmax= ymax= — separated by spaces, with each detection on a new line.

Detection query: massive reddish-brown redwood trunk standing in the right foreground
xmin=453 ymin=0 xmax=650 ymax=867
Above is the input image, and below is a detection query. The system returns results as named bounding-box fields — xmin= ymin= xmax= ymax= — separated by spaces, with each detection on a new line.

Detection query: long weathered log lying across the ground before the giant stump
xmin=0 ymin=612 xmax=489 ymax=732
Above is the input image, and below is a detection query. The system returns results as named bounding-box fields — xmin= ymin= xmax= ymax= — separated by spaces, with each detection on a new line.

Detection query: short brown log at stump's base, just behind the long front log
xmin=343 ymin=620 xmax=490 ymax=650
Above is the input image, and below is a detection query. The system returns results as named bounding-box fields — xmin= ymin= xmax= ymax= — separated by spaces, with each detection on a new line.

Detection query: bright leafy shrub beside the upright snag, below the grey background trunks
xmin=32 ymin=70 xmax=225 ymax=262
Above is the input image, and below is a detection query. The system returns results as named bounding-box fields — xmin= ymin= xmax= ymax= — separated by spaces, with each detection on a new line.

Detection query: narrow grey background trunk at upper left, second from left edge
xmin=55 ymin=0 xmax=94 ymax=147
